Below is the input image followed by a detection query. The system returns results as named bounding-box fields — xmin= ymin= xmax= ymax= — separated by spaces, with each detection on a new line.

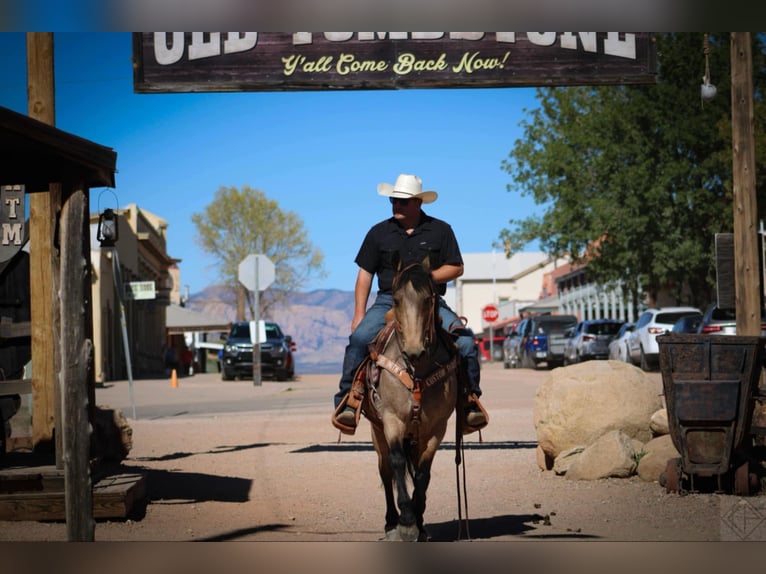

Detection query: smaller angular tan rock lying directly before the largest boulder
xmin=568 ymin=430 xmax=636 ymax=480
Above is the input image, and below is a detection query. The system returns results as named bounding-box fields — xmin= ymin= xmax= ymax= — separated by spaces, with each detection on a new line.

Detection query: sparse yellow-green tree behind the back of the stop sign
xmin=192 ymin=185 xmax=324 ymax=320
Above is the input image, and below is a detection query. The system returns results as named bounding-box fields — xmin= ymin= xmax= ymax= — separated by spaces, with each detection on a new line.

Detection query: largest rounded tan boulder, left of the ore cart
xmin=534 ymin=361 xmax=663 ymax=459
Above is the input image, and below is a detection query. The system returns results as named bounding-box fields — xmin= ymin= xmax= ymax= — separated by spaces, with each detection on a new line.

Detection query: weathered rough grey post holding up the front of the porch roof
xmin=59 ymin=187 xmax=95 ymax=542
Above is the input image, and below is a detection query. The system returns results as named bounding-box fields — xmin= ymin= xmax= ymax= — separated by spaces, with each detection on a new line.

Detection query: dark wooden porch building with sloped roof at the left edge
xmin=0 ymin=102 xmax=134 ymax=540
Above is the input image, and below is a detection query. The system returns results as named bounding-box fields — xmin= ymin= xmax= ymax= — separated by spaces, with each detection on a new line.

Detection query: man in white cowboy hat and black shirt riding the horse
xmin=332 ymin=174 xmax=488 ymax=434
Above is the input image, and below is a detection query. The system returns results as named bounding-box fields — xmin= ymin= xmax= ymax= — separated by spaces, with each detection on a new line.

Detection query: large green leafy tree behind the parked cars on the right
xmin=500 ymin=33 xmax=766 ymax=316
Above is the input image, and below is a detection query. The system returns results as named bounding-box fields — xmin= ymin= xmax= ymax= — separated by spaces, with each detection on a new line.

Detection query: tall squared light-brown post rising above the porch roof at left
xmin=26 ymin=32 xmax=63 ymax=468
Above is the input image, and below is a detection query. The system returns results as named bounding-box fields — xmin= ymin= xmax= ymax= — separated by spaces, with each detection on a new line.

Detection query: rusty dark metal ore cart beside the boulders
xmin=657 ymin=334 xmax=766 ymax=496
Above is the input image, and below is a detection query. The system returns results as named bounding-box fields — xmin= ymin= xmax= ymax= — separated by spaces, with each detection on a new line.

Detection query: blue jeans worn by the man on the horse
xmin=334 ymin=293 xmax=481 ymax=408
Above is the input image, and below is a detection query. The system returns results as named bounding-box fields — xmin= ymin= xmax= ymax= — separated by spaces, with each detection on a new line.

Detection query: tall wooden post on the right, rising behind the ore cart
xmin=731 ymin=32 xmax=761 ymax=336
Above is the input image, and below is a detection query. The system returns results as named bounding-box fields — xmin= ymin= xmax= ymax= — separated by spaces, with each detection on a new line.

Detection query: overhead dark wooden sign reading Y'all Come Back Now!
xmin=133 ymin=32 xmax=657 ymax=93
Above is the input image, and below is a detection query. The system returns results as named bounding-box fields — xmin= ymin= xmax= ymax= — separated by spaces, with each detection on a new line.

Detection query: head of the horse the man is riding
xmin=392 ymin=258 xmax=437 ymax=364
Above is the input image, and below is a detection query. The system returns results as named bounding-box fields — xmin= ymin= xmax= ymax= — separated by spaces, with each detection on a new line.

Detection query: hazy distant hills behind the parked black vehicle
xmin=186 ymin=285 xmax=354 ymax=375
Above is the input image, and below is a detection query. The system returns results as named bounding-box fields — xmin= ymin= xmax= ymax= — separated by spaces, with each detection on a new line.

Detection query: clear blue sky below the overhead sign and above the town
xmin=0 ymin=32 xmax=538 ymax=294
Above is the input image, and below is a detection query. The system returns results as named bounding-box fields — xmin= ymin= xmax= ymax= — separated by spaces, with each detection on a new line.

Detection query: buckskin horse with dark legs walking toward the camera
xmin=362 ymin=259 xmax=459 ymax=541
